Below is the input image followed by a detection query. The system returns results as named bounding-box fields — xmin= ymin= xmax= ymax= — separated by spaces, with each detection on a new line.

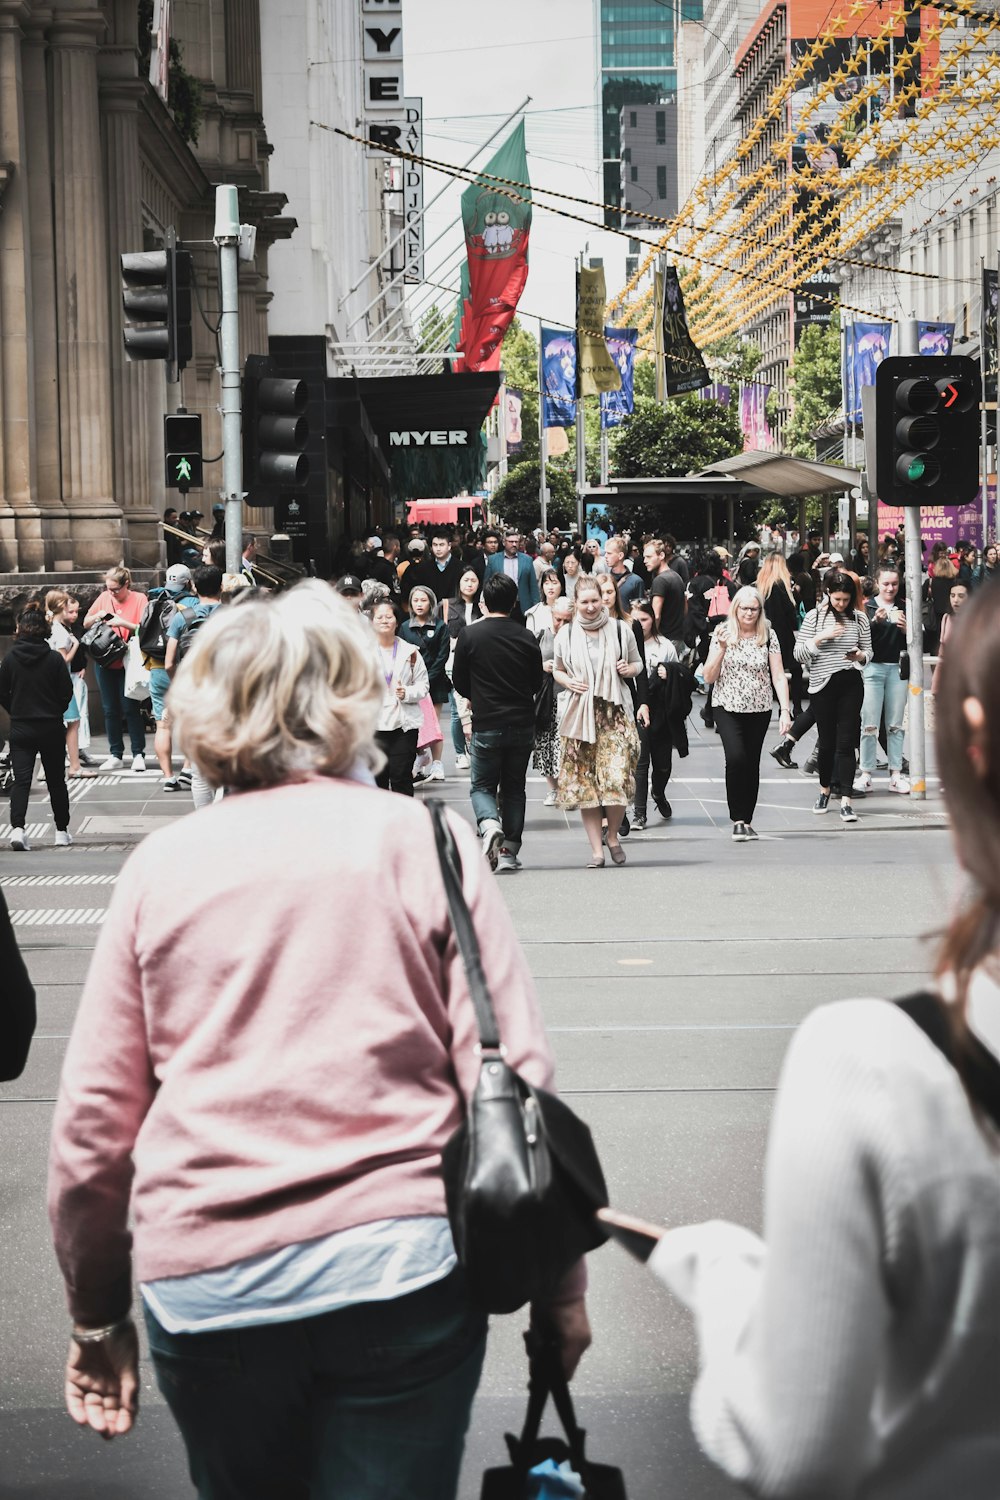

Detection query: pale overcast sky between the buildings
xmin=403 ymin=0 xmax=627 ymax=333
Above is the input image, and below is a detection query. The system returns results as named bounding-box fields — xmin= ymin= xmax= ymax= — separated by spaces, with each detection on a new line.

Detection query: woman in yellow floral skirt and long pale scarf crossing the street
xmin=552 ymin=578 xmax=645 ymax=870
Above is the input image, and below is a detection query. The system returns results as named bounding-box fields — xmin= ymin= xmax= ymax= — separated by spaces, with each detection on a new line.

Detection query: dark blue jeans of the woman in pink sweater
xmin=145 ymin=1271 xmax=486 ymax=1500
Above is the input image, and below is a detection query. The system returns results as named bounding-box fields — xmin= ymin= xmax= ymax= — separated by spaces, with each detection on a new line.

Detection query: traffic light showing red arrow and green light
xmin=874 ymin=354 xmax=982 ymax=506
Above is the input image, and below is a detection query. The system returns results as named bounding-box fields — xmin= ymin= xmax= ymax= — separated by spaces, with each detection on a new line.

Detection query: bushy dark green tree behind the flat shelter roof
xmin=609 ymin=396 xmax=744 ymax=536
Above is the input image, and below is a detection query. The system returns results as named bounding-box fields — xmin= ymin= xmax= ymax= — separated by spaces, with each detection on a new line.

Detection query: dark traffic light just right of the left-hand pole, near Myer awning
xmin=243 ymin=354 xmax=309 ymax=506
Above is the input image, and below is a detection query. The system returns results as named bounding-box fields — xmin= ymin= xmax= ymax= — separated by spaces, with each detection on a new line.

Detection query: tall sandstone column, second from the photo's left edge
xmin=49 ymin=0 xmax=121 ymax=567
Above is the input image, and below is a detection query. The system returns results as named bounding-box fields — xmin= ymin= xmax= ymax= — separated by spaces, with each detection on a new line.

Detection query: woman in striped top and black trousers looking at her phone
xmin=795 ymin=572 xmax=871 ymax=824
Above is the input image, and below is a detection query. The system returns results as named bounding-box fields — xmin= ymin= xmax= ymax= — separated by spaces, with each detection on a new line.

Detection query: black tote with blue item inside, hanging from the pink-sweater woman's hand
xmin=480 ymin=1328 xmax=628 ymax=1500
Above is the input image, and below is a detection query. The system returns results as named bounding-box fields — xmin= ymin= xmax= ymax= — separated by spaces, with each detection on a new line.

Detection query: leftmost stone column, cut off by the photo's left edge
xmin=0 ymin=0 xmax=40 ymax=569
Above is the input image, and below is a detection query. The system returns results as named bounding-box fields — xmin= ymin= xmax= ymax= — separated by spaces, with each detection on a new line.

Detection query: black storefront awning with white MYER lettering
xmin=327 ymin=372 xmax=501 ymax=500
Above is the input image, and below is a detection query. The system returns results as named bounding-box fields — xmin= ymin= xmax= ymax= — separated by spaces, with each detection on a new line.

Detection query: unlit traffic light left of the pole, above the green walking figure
xmin=121 ymin=230 xmax=193 ymax=384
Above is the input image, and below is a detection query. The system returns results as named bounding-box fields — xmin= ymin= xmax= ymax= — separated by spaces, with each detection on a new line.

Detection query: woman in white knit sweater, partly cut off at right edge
xmin=638 ymin=590 xmax=1000 ymax=1500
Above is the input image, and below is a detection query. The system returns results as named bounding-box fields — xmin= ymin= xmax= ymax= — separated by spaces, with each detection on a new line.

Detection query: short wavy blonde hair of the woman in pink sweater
xmin=169 ymin=579 xmax=382 ymax=791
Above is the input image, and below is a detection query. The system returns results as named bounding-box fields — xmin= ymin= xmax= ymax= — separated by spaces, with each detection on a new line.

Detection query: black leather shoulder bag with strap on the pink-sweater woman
xmin=430 ymin=801 xmax=607 ymax=1313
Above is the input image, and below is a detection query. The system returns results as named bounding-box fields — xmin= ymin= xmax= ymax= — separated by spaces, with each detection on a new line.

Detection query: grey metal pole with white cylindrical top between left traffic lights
xmin=214 ymin=186 xmax=243 ymax=573
